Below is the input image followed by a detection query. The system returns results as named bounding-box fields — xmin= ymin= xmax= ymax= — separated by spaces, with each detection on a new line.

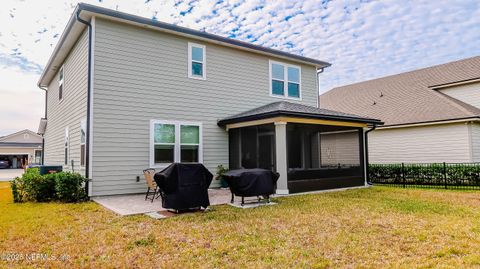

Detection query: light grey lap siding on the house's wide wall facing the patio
xmin=92 ymin=19 xmax=318 ymax=195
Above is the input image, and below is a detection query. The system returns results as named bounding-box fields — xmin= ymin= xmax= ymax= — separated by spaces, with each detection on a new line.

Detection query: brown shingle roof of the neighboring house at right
xmin=320 ymin=56 xmax=480 ymax=126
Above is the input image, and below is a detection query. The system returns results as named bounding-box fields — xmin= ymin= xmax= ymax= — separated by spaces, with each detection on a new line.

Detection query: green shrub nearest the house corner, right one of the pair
xmin=51 ymin=172 xmax=87 ymax=203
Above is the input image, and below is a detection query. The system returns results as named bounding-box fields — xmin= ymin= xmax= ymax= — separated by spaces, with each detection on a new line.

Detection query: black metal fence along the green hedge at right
xmin=368 ymin=163 xmax=480 ymax=190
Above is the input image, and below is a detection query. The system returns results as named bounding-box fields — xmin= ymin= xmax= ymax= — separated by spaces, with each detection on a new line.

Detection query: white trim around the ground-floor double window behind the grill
xmin=149 ymin=120 xmax=203 ymax=168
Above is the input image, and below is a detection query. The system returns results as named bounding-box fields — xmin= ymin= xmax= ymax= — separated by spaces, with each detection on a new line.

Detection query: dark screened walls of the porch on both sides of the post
xmin=229 ymin=123 xmax=364 ymax=193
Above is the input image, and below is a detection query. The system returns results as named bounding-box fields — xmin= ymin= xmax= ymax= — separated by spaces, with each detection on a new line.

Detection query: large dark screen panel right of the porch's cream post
xmin=287 ymin=123 xmax=362 ymax=180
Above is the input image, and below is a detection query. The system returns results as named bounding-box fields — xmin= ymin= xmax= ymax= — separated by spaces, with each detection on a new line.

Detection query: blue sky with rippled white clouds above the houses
xmin=0 ymin=0 xmax=480 ymax=135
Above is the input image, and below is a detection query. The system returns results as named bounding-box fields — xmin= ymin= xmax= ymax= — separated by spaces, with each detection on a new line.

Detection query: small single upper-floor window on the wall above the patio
xmin=188 ymin=42 xmax=207 ymax=80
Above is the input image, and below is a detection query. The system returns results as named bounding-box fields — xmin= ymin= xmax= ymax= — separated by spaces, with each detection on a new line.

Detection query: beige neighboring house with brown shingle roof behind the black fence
xmin=320 ymin=56 xmax=480 ymax=163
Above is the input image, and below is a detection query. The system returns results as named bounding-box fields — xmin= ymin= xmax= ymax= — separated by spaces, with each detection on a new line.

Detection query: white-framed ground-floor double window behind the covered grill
xmin=150 ymin=120 xmax=203 ymax=168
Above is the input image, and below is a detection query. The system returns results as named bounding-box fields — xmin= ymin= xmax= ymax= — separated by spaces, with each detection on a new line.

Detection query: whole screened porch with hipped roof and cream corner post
xmin=218 ymin=101 xmax=382 ymax=194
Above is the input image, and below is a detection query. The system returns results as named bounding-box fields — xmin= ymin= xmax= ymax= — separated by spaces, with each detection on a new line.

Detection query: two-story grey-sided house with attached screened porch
xmin=38 ymin=4 xmax=380 ymax=196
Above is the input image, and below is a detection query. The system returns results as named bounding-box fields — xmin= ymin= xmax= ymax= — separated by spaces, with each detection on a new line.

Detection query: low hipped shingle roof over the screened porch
xmin=218 ymin=101 xmax=381 ymax=126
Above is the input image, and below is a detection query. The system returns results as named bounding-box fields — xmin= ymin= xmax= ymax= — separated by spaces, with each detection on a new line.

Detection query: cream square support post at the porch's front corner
xmin=275 ymin=121 xmax=288 ymax=194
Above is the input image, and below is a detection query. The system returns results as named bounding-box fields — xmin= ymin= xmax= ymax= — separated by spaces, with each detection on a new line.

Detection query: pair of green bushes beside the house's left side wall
xmin=11 ymin=168 xmax=87 ymax=203
